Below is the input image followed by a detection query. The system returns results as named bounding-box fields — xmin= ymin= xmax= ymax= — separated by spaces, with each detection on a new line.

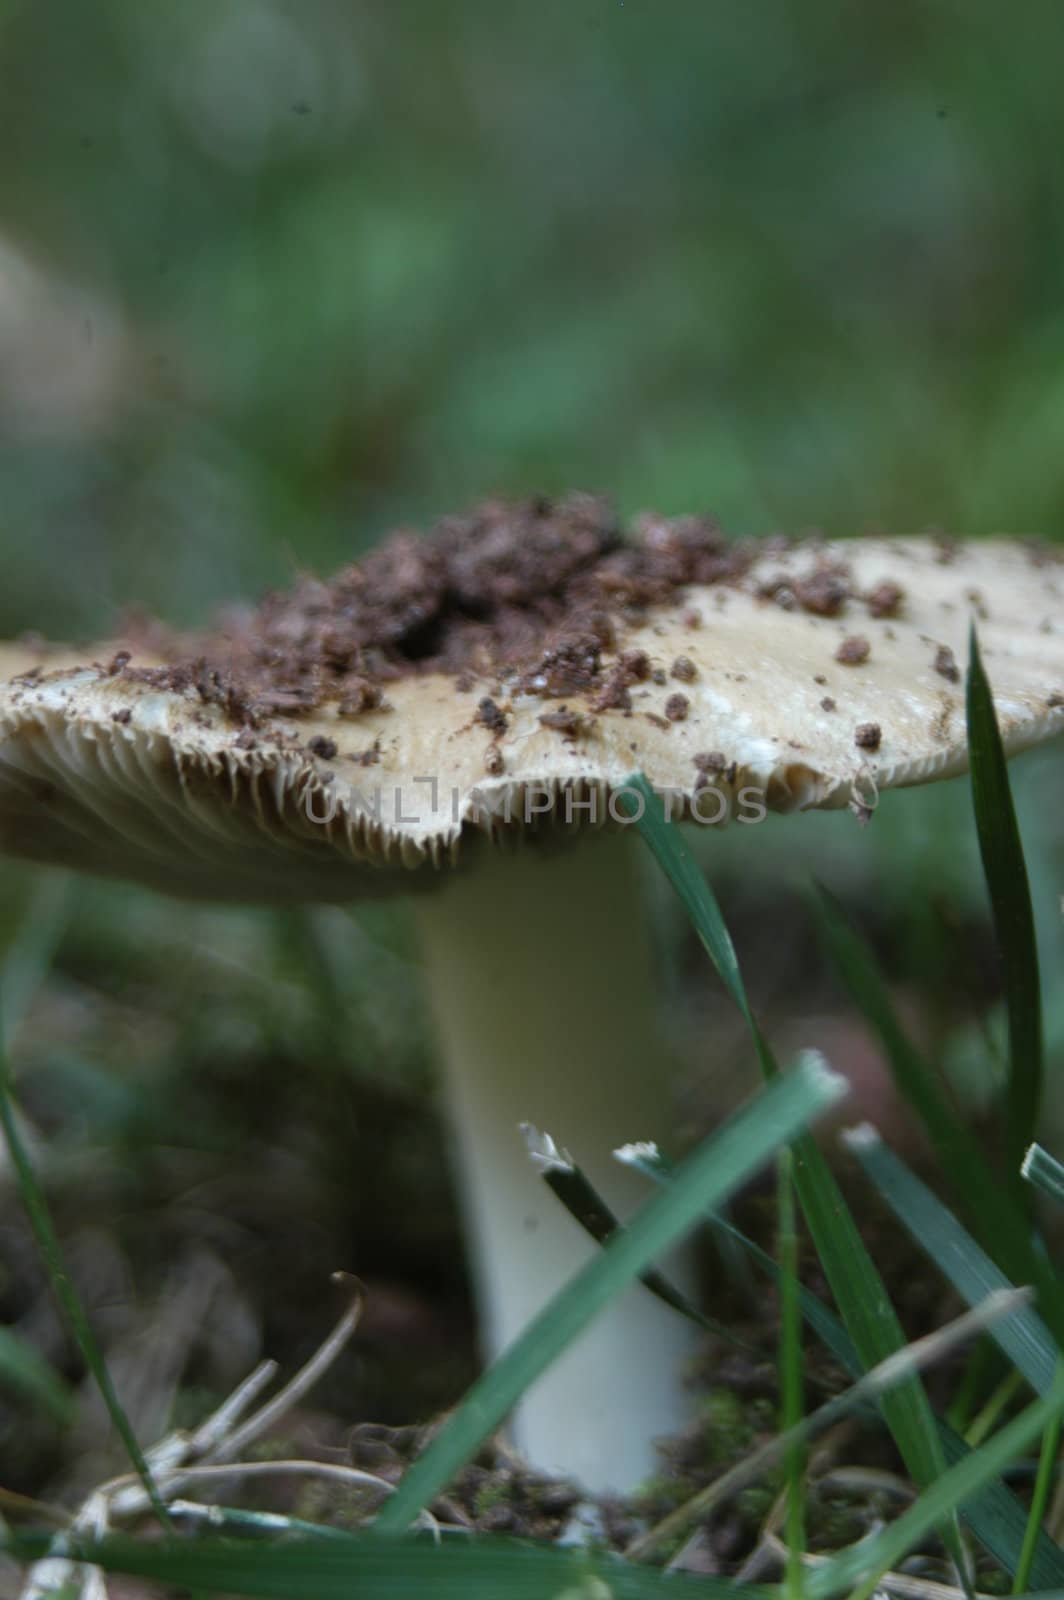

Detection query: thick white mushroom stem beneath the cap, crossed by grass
xmin=419 ymin=830 xmax=696 ymax=1491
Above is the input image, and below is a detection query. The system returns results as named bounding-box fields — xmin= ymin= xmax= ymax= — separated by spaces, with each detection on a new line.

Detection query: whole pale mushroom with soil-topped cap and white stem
xmin=0 ymin=498 xmax=1064 ymax=1490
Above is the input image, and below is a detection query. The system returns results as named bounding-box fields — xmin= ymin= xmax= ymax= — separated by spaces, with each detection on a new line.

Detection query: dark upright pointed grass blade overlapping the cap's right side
xmin=966 ymin=626 xmax=1043 ymax=1173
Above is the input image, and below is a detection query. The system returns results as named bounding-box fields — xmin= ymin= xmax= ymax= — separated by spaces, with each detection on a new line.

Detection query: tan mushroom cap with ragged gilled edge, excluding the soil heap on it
xmin=0 ymin=538 xmax=1064 ymax=899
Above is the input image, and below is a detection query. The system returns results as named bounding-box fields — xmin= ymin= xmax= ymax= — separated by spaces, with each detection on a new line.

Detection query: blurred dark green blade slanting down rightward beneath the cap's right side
xmin=811 ymin=885 xmax=1064 ymax=1347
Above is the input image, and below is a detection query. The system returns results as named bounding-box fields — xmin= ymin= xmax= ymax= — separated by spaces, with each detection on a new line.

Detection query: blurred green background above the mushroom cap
xmin=0 ymin=0 xmax=1064 ymax=632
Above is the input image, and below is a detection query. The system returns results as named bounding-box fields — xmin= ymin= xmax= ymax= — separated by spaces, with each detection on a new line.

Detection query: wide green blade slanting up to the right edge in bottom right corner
xmin=806 ymin=1376 xmax=1064 ymax=1600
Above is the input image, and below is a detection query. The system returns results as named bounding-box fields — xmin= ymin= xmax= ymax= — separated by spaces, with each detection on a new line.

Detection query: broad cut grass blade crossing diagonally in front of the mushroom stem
xmin=376 ymin=1054 xmax=842 ymax=1533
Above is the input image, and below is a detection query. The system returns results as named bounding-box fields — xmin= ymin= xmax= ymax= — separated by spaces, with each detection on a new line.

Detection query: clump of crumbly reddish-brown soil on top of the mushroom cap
xmin=95 ymin=494 xmax=1056 ymax=731
